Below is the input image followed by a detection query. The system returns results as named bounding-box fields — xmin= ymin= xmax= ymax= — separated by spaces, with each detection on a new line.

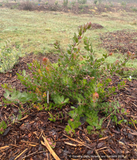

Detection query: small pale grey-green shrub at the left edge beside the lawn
xmin=0 ymin=42 xmax=21 ymax=73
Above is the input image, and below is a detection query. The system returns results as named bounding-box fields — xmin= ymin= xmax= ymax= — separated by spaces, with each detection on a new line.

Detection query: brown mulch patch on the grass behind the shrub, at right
xmin=100 ymin=30 xmax=137 ymax=57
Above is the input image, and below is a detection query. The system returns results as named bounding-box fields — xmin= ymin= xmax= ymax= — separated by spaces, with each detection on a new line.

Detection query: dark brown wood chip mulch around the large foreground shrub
xmin=0 ymin=53 xmax=137 ymax=160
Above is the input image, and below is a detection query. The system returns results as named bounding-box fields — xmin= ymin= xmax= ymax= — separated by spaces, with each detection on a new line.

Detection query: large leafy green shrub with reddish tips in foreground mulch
xmin=3 ymin=22 xmax=132 ymax=133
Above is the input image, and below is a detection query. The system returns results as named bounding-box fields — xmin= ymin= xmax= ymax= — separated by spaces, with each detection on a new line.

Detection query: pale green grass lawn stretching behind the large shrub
xmin=0 ymin=9 xmax=137 ymax=67
